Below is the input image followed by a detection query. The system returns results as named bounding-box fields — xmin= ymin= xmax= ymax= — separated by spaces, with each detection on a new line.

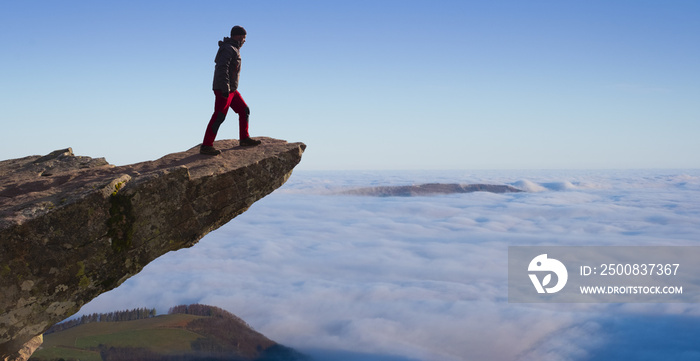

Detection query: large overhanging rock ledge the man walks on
xmin=0 ymin=138 xmax=306 ymax=360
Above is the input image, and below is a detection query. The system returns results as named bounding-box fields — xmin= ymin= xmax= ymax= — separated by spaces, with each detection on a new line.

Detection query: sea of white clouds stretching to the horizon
xmin=80 ymin=170 xmax=700 ymax=361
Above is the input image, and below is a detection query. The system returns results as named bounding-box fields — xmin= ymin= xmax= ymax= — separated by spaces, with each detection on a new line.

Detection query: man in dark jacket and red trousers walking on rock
xmin=199 ymin=25 xmax=261 ymax=155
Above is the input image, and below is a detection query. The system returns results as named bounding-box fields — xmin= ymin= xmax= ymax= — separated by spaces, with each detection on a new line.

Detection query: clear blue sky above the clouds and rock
xmin=0 ymin=1 xmax=700 ymax=170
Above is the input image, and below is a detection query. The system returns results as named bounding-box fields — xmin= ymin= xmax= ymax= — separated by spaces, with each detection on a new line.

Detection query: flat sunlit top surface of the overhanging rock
xmin=0 ymin=137 xmax=306 ymax=229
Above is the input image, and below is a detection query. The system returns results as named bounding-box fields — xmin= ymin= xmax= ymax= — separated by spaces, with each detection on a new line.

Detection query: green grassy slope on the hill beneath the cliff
xmin=32 ymin=314 xmax=201 ymax=361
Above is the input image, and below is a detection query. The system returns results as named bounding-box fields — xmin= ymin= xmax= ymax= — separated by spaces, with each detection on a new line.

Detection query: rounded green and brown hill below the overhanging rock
xmin=30 ymin=304 xmax=309 ymax=361
